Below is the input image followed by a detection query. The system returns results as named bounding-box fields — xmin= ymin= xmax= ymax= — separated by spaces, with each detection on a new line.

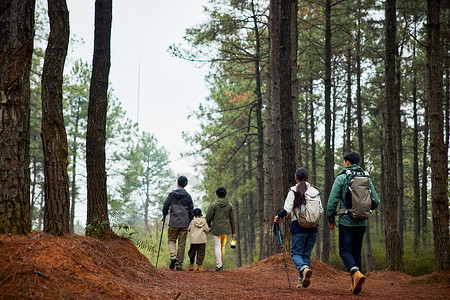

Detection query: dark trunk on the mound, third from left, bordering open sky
xmin=86 ymin=0 xmax=112 ymax=230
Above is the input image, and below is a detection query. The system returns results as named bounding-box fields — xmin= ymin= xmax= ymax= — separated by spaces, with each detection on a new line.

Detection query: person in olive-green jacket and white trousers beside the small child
xmin=206 ymin=187 xmax=235 ymax=271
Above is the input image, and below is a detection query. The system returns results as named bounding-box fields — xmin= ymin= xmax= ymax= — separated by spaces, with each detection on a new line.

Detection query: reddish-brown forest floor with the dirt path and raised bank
xmin=0 ymin=232 xmax=450 ymax=299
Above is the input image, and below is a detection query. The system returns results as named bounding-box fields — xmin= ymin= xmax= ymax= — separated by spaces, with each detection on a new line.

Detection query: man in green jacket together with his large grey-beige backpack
xmin=327 ymin=152 xmax=380 ymax=295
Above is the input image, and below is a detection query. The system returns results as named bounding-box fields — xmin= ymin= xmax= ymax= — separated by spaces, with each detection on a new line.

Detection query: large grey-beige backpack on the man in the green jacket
xmin=337 ymin=170 xmax=372 ymax=220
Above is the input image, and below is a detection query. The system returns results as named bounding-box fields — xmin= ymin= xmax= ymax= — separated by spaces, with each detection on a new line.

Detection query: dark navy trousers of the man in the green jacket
xmin=339 ymin=224 xmax=366 ymax=272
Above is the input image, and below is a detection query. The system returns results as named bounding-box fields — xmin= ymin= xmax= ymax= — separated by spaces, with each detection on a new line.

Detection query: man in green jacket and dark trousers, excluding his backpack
xmin=327 ymin=152 xmax=380 ymax=295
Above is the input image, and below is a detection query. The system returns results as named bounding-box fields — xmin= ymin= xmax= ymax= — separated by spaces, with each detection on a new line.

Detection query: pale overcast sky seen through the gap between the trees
xmin=66 ymin=0 xmax=208 ymax=177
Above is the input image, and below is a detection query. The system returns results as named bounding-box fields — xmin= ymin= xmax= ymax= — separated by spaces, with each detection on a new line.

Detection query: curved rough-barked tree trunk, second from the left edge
xmin=42 ymin=0 xmax=70 ymax=235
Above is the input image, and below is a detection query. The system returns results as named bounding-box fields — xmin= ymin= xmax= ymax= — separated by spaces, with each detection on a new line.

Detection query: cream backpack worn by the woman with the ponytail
xmin=291 ymin=186 xmax=321 ymax=228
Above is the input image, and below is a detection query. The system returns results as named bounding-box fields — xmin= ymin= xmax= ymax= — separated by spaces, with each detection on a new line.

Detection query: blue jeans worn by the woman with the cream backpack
xmin=291 ymin=233 xmax=317 ymax=279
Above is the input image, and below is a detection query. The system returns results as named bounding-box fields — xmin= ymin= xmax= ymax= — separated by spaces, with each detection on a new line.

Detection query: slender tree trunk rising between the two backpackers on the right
xmin=322 ymin=0 xmax=334 ymax=263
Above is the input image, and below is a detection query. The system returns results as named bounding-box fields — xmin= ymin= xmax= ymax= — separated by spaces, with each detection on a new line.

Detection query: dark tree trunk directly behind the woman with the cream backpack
xmin=278 ymin=0 xmax=298 ymax=249
